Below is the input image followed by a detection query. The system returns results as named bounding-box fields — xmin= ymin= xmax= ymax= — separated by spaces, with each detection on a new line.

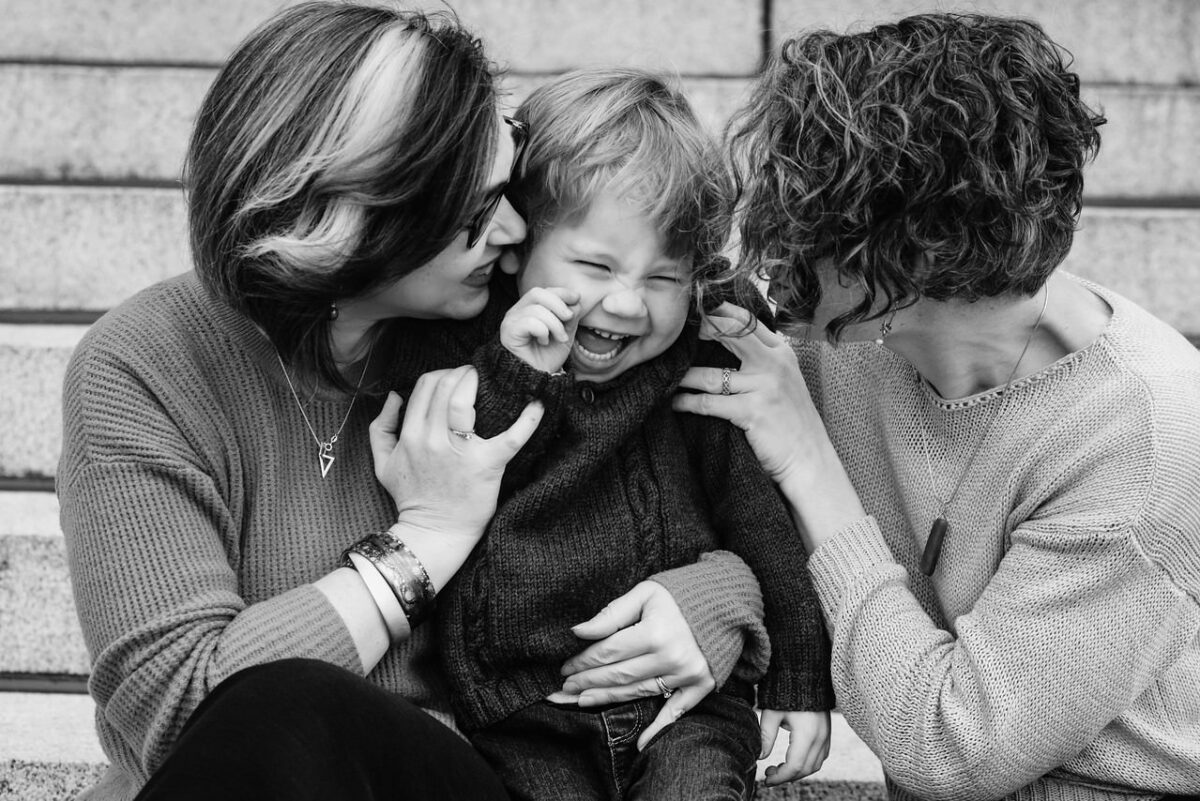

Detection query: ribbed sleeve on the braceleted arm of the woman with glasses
xmin=58 ymin=348 xmax=364 ymax=778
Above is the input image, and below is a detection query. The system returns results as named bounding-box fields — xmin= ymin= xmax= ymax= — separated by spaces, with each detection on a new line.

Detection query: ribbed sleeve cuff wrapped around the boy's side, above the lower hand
xmin=650 ymin=550 xmax=770 ymax=687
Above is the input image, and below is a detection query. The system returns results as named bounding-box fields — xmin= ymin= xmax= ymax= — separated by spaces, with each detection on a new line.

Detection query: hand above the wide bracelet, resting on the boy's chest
xmin=371 ymin=366 xmax=542 ymax=589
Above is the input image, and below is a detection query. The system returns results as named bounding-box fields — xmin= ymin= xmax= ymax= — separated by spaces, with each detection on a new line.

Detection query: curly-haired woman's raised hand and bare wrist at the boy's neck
xmin=672 ymin=303 xmax=866 ymax=553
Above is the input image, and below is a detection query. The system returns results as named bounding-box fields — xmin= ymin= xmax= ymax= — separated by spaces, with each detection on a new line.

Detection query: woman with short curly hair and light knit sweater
xmin=676 ymin=14 xmax=1200 ymax=800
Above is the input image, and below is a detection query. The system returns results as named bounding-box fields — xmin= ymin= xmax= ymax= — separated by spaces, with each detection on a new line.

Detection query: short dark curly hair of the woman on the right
xmin=730 ymin=13 xmax=1105 ymax=341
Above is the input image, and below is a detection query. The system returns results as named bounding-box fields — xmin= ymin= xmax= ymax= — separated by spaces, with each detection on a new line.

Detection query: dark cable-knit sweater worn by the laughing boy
xmin=439 ymin=276 xmax=833 ymax=731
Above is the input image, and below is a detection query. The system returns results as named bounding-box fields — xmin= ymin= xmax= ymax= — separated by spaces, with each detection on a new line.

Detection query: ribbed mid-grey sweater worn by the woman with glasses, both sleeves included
xmin=58 ymin=273 xmax=761 ymax=801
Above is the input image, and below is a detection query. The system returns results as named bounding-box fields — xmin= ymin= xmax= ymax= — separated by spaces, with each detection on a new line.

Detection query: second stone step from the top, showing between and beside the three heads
xmin=0 ymin=65 xmax=1200 ymax=199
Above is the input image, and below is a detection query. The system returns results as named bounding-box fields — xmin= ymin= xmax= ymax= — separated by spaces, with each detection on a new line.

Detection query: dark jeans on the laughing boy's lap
xmin=472 ymin=692 xmax=760 ymax=801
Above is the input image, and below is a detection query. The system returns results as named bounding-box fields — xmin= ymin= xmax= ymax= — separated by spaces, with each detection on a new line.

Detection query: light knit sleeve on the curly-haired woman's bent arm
xmin=810 ymin=510 xmax=1200 ymax=800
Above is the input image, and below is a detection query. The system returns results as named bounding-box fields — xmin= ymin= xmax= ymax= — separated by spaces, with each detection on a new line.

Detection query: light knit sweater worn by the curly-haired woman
xmin=794 ymin=275 xmax=1200 ymax=801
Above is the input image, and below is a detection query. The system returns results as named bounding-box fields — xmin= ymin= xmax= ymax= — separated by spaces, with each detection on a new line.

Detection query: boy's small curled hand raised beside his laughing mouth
xmin=500 ymin=287 xmax=580 ymax=373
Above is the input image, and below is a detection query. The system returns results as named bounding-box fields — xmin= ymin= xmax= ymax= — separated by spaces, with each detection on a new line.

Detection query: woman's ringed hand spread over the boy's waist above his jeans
xmin=547 ymin=582 xmax=716 ymax=748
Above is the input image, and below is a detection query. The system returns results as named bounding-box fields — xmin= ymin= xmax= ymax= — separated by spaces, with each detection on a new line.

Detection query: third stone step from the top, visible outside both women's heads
xmin=0 ymin=195 xmax=1200 ymax=323
